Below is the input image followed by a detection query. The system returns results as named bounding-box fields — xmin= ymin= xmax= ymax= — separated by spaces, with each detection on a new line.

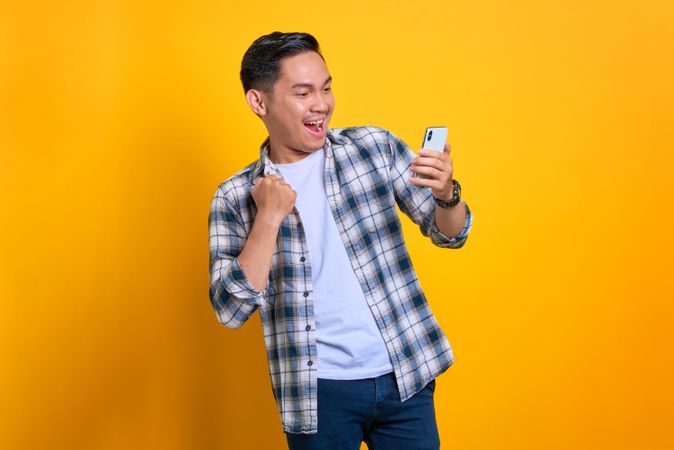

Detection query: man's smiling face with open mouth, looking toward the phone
xmin=263 ymin=51 xmax=335 ymax=162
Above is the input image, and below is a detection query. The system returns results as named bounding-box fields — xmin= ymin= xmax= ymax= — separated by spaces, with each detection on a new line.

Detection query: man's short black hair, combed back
xmin=240 ymin=31 xmax=325 ymax=94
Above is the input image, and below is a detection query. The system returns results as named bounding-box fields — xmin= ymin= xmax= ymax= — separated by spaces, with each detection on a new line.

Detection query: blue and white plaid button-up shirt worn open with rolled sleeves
xmin=208 ymin=126 xmax=472 ymax=433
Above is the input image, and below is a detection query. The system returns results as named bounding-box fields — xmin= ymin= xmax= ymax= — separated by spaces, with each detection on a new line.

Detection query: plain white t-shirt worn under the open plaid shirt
xmin=275 ymin=149 xmax=393 ymax=380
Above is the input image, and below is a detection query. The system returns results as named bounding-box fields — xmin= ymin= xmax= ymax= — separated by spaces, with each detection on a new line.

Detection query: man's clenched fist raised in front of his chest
xmin=251 ymin=175 xmax=297 ymax=225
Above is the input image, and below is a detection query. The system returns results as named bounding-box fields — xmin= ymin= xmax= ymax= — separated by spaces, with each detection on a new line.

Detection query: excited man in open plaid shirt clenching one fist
xmin=209 ymin=32 xmax=472 ymax=450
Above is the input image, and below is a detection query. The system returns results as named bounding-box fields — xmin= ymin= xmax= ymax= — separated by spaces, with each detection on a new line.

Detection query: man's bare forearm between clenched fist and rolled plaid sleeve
xmin=239 ymin=215 xmax=280 ymax=291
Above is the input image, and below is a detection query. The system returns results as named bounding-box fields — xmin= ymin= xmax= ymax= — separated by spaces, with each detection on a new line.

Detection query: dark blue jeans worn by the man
xmin=286 ymin=372 xmax=440 ymax=450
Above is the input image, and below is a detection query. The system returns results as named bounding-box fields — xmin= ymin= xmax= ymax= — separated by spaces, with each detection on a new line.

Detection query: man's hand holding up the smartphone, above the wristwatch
xmin=410 ymin=144 xmax=454 ymax=200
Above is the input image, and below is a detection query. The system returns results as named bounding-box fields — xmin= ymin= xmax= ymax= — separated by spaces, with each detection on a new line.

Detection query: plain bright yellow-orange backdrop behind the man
xmin=0 ymin=0 xmax=674 ymax=450
